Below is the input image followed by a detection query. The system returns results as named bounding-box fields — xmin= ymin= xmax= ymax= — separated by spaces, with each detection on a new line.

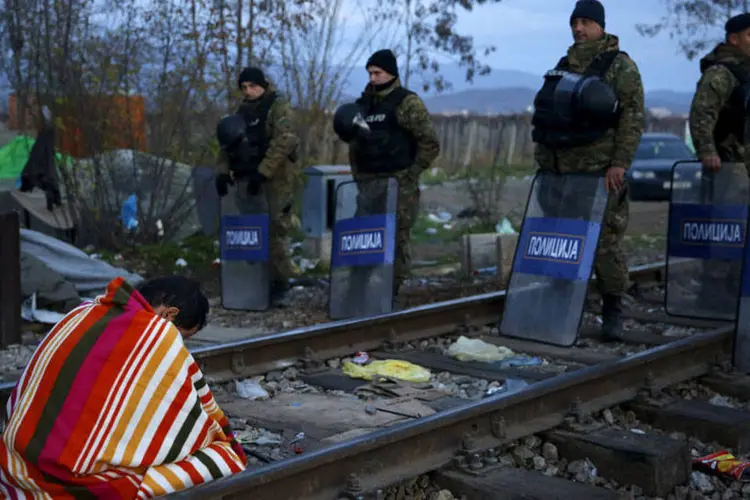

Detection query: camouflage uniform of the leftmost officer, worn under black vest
xmin=217 ymin=86 xmax=299 ymax=287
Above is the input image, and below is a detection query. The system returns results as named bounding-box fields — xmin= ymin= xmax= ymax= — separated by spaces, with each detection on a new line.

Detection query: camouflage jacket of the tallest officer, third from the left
xmin=534 ymin=34 xmax=645 ymax=173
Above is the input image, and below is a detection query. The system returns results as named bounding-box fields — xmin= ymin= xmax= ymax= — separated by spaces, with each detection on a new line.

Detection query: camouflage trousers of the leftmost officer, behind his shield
xmin=235 ymin=179 xmax=295 ymax=283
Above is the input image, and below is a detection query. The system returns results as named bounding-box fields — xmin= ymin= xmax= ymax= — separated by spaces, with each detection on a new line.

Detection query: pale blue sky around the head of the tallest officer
xmin=348 ymin=0 xmax=736 ymax=91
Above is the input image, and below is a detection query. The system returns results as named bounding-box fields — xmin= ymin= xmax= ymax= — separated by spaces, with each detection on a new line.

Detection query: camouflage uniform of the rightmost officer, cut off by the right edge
xmin=689 ymin=43 xmax=750 ymax=313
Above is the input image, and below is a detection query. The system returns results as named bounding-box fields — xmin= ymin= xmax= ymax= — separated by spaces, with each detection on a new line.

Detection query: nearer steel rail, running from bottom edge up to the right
xmin=168 ymin=326 xmax=734 ymax=500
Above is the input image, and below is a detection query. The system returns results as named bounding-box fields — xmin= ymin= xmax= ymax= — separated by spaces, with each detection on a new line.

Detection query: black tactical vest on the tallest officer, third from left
xmin=531 ymin=50 xmax=627 ymax=149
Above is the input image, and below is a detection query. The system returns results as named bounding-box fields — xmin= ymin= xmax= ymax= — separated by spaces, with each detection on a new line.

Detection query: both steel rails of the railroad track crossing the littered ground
xmin=0 ymin=263 xmax=734 ymax=500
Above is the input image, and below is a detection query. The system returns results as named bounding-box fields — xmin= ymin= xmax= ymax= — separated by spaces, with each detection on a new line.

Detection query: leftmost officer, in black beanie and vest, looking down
xmin=216 ymin=67 xmax=299 ymax=305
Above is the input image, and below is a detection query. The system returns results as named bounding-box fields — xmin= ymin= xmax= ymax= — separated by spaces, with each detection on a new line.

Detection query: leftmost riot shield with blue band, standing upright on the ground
xmin=219 ymin=181 xmax=271 ymax=311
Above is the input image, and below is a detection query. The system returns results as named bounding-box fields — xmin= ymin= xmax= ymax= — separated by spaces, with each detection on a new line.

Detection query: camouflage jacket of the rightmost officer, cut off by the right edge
xmin=690 ymin=43 xmax=750 ymax=161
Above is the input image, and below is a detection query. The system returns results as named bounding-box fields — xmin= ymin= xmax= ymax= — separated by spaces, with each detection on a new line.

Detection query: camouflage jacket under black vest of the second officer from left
xmin=349 ymin=79 xmax=440 ymax=177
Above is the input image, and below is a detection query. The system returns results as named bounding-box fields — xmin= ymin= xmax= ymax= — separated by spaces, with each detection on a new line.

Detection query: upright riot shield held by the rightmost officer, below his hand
xmin=664 ymin=161 xmax=748 ymax=321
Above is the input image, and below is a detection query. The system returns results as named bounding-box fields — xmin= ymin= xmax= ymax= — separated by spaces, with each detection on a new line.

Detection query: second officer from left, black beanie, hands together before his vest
xmin=349 ymin=49 xmax=440 ymax=297
